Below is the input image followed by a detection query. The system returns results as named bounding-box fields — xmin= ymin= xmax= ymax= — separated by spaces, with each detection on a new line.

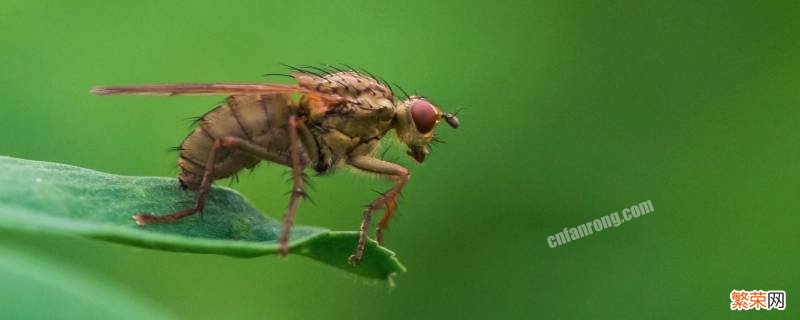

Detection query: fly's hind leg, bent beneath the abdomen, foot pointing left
xmin=133 ymin=136 xmax=289 ymax=225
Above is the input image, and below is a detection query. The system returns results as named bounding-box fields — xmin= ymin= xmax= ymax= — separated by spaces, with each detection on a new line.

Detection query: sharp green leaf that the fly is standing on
xmin=0 ymin=157 xmax=405 ymax=279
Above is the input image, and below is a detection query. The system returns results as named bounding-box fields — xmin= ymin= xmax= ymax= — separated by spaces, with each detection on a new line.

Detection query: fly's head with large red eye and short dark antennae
xmin=395 ymin=96 xmax=459 ymax=163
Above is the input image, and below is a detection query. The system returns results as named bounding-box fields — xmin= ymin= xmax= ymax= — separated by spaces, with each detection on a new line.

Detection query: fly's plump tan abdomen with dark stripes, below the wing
xmin=178 ymin=95 xmax=291 ymax=190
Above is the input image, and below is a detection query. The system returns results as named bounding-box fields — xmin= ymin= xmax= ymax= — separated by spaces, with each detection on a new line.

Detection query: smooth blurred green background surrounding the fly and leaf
xmin=0 ymin=0 xmax=800 ymax=319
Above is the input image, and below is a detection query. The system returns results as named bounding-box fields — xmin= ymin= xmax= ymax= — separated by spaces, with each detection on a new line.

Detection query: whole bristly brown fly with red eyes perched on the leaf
xmin=92 ymin=65 xmax=459 ymax=265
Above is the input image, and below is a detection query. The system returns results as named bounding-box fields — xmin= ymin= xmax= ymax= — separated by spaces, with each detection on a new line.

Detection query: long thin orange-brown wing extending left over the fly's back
xmin=92 ymin=83 xmax=345 ymax=104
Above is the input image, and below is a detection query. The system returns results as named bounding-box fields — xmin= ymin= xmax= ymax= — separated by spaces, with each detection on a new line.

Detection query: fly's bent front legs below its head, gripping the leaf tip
xmin=348 ymin=156 xmax=411 ymax=265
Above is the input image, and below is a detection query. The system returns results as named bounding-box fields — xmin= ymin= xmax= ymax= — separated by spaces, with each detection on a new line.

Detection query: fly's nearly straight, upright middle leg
xmin=278 ymin=115 xmax=308 ymax=257
